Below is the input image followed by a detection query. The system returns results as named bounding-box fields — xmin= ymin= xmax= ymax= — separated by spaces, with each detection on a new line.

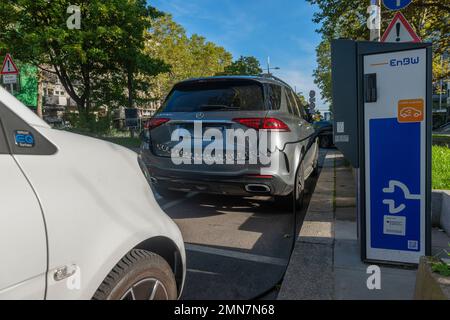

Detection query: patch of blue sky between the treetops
xmin=149 ymin=0 xmax=328 ymax=110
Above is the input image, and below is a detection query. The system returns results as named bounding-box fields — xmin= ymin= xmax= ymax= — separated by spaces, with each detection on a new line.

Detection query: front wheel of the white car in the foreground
xmin=93 ymin=249 xmax=177 ymax=300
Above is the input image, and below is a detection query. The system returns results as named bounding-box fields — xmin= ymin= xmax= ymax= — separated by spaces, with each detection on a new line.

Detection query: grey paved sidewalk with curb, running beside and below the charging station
xmin=278 ymin=150 xmax=448 ymax=300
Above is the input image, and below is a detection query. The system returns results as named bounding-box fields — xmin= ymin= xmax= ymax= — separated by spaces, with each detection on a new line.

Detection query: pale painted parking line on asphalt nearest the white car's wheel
xmin=185 ymin=243 xmax=289 ymax=267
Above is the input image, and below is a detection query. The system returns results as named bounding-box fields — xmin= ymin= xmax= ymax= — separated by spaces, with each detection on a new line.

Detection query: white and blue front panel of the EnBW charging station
xmin=363 ymin=49 xmax=427 ymax=263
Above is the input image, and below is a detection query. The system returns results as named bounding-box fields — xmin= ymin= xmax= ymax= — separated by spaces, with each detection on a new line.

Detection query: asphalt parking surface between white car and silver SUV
xmin=156 ymin=152 xmax=323 ymax=300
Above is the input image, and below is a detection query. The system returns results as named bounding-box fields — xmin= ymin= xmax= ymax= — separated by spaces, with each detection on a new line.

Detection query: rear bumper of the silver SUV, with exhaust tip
xmin=140 ymin=139 xmax=302 ymax=196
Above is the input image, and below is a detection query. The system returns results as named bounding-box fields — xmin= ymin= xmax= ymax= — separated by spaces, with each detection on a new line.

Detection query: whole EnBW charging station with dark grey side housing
xmin=331 ymin=40 xmax=432 ymax=265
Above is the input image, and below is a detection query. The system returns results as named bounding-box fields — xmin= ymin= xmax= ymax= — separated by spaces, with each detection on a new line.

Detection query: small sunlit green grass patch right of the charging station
xmin=432 ymin=146 xmax=450 ymax=190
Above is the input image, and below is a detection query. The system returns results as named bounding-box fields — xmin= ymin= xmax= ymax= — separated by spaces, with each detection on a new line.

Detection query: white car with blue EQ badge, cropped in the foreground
xmin=0 ymin=87 xmax=185 ymax=299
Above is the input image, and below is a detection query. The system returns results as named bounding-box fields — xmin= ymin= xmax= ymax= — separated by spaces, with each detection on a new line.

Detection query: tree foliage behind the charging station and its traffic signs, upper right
xmin=308 ymin=0 xmax=450 ymax=102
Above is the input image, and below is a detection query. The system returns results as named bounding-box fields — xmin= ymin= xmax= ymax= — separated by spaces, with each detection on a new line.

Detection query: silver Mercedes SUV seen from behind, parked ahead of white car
xmin=141 ymin=76 xmax=318 ymax=209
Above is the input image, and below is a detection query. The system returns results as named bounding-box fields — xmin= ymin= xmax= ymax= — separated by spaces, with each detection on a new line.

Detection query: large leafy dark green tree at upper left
xmin=0 ymin=0 xmax=168 ymax=118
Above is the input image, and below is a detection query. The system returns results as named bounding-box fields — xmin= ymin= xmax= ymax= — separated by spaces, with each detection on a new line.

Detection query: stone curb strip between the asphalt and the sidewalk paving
xmin=277 ymin=150 xmax=337 ymax=300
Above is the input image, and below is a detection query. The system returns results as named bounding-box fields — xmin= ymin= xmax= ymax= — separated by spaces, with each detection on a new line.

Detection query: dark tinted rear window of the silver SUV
xmin=161 ymin=81 xmax=265 ymax=112
